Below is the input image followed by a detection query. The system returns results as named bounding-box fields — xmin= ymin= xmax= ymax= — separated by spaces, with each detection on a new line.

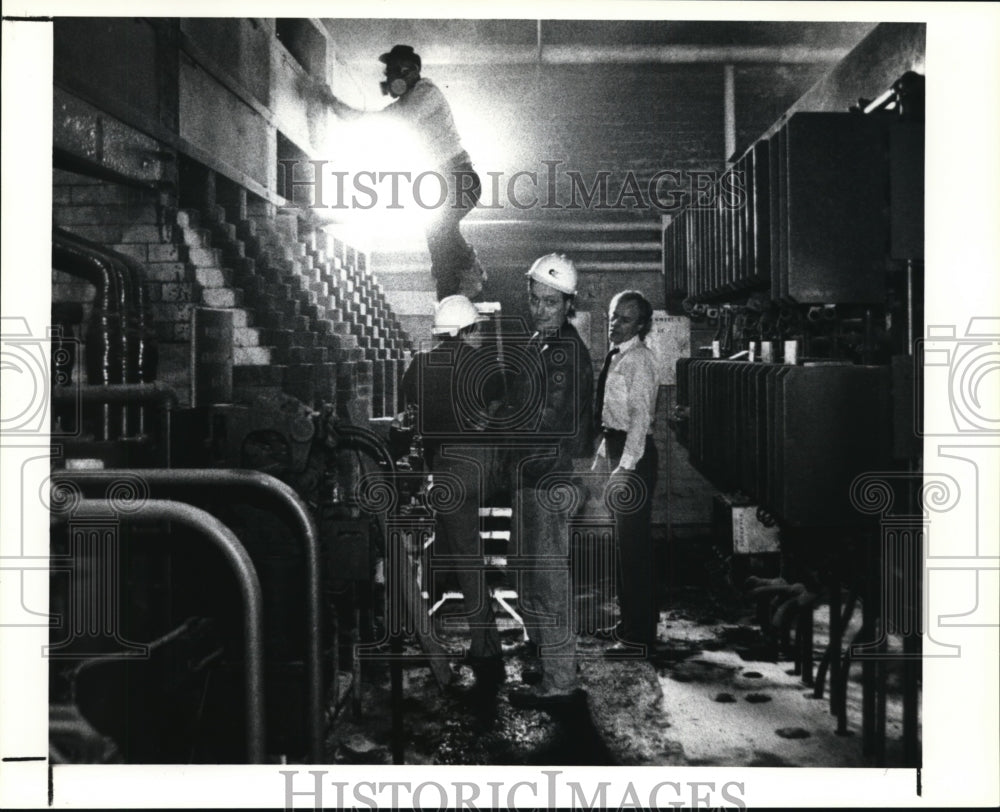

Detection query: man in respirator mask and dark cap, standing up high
xmin=301 ymin=45 xmax=486 ymax=300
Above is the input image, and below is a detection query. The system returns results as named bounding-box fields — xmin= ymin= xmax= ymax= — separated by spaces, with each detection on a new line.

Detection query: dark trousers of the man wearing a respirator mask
xmin=426 ymin=161 xmax=482 ymax=301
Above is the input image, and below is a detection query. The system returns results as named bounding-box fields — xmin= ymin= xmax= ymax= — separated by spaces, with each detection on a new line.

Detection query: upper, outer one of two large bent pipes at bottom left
xmin=52 ymin=468 xmax=324 ymax=764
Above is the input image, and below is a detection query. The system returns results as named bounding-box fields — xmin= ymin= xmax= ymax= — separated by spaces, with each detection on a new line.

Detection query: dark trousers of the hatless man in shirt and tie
xmin=604 ymin=432 xmax=659 ymax=645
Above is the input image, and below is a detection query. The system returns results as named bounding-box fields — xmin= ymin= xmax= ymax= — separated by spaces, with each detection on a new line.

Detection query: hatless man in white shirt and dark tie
xmin=594 ymin=290 xmax=659 ymax=655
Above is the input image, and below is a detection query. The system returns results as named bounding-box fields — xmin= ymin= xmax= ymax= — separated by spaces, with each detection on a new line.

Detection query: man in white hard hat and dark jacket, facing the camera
xmin=508 ymin=254 xmax=594 ymax=709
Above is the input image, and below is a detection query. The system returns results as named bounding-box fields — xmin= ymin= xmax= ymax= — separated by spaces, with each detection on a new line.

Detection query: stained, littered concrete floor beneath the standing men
xmin=328 ymin=576 xmax=916 ymax=767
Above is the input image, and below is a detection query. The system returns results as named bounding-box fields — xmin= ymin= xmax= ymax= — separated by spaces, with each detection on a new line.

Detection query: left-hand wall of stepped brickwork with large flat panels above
xmin=53 ymin=18 xmax=408 ymax=424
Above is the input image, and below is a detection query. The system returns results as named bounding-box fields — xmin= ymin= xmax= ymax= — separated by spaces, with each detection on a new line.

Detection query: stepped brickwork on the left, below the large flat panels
xmin=53 ymin=170 xmax=409 ymax=418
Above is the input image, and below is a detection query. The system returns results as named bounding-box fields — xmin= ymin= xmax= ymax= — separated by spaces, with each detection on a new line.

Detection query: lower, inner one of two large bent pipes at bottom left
xmin=62 ymin=499 xmax=264 ymax=764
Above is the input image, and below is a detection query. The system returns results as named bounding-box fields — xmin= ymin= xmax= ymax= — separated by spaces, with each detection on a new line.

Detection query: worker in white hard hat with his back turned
xmin=402 ymin=294 xmax=506 ymax=703
